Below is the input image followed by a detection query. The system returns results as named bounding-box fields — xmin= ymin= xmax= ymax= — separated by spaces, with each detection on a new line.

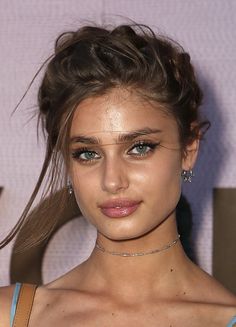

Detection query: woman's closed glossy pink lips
xmin=99 ymin=199 xmax=141 ymax=218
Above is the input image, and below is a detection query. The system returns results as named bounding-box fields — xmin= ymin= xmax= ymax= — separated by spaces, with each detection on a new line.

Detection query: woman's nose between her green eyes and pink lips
xmin=102 ymin=157 xmax=129 ymax=194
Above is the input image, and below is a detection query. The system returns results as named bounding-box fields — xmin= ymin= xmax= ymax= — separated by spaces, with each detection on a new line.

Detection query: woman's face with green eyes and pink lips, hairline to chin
xmin=70 ymin=90 xmax=196 ymax=240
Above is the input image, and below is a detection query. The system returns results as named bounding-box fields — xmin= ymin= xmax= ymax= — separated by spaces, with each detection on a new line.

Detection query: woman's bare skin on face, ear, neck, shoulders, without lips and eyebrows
xmin=0 ymin=90 xmax=236 ymax=327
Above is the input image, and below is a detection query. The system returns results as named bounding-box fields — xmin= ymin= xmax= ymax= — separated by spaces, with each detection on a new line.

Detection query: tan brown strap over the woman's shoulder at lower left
xmin=12 ymin=284 xmax=37 ymax=327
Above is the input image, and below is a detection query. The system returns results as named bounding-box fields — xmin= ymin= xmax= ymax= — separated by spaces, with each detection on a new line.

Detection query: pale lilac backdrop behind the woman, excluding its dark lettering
xmin=0 ymin=0 xmax=236 ymax=285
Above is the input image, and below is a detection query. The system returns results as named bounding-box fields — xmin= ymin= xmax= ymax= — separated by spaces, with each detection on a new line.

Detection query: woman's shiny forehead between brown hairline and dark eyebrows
xmin=70 ymin=90 xmax=178 ymax=141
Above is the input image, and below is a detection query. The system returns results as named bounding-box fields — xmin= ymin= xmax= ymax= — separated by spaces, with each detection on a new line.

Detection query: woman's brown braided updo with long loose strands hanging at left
xmin=1 ymin=24 xmax=209 ymax=254
